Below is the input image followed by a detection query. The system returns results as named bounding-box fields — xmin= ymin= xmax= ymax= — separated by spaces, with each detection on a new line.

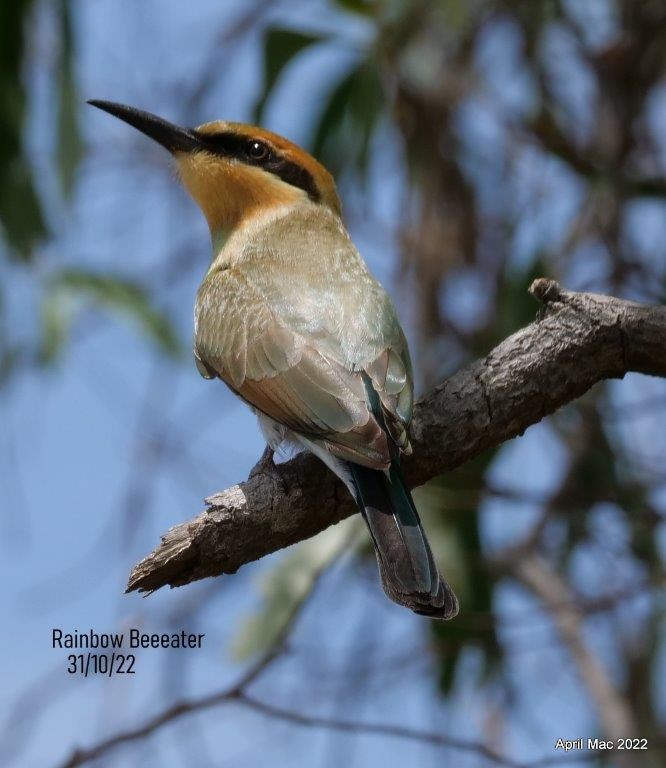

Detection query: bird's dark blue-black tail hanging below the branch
xmin=348 ymin=460 xmax=458 ymax=619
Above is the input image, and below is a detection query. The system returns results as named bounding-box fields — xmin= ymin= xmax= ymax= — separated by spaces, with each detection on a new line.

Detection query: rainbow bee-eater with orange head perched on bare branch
xmin=88 ymin=100 xmax=458 ymax=619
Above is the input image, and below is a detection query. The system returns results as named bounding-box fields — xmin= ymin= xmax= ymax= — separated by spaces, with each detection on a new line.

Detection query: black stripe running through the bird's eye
xmin=191 ymin=133 xmax=321 ymax=203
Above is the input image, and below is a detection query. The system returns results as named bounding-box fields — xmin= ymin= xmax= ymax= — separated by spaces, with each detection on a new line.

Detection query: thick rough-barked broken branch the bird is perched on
xmin=127 ymin=278 xmax=666 ymax=592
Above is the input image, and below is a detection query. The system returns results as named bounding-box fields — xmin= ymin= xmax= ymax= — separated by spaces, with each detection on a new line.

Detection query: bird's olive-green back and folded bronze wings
xmin=195 ymin=210 xmax=412 ymax=468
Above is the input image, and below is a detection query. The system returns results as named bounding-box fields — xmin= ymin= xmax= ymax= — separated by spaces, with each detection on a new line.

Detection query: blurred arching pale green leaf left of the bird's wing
xmin=41 ymin=269 xmax=182 ymax=363
